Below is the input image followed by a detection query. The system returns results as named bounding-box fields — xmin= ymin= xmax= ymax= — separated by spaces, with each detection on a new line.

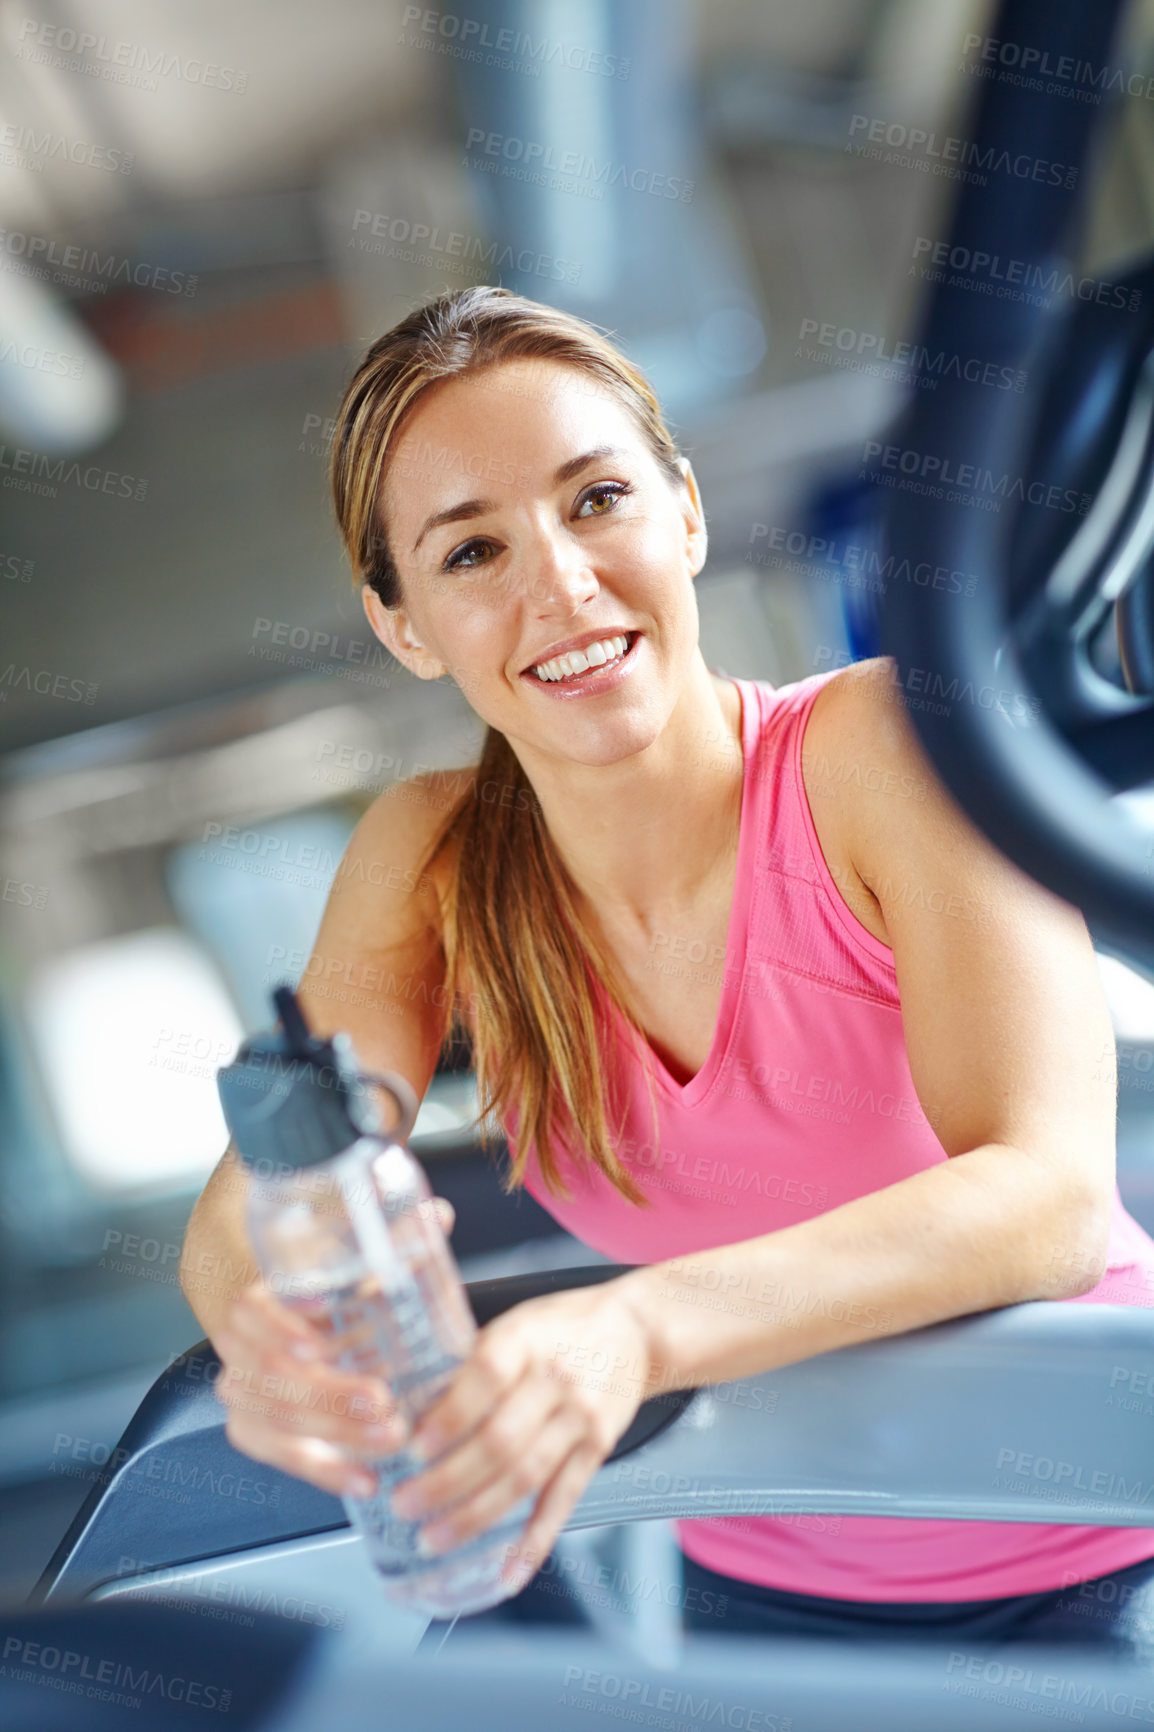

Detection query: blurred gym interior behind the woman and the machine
xmin=0 ymin=0 xmax=1154 ymax=1602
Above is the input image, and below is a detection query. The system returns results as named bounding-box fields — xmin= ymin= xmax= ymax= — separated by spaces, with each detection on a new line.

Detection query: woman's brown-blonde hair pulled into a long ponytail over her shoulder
xmin=329 ymin=286 xmax=684 ymax=1207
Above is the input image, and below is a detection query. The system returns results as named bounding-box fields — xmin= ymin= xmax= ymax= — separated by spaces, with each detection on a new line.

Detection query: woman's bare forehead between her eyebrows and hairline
xmin=385 ymin=360 xmax=648 ymax=516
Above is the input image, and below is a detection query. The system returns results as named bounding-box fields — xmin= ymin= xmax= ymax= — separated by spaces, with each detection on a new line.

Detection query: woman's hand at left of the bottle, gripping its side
xmin=213 ymin=1197 xmax=452 ymax=1496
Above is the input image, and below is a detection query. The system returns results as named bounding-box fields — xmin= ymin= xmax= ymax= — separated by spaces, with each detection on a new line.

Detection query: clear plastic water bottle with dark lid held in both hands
xmin=217 ymin=987 xmax=535 ymax=1618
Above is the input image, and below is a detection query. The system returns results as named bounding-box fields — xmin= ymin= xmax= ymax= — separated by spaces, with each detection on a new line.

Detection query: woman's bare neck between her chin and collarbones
xmin=509 ymin=650 xmax=743 ymax=932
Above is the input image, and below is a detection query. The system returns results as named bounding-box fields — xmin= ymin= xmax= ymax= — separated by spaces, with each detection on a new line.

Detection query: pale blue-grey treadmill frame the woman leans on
xmin=26 ymin=1264 xmax=1154 ymax=1732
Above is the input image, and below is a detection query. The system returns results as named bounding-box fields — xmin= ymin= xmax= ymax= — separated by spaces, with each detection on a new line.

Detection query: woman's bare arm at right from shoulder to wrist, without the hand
xmin=620 ymin=663 xmax=1114 ymax=1389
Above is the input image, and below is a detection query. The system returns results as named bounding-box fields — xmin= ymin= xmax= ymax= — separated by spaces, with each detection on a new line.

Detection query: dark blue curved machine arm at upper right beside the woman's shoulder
xmin=866 ymin=0 xmax=1154 ymax=968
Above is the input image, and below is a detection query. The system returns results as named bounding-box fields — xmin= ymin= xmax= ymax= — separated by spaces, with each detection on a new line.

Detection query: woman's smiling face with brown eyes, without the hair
xmin=364 ymin=360 xmax=705 ymax=764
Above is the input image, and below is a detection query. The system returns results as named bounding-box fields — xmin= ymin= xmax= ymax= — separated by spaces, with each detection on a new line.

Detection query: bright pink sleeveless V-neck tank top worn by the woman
xmin=506 ymin=672 xmax=1154 ymax=1602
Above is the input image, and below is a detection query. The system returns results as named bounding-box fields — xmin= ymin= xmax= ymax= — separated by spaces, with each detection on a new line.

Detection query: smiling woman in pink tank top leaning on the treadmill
xmin=182 ymin=288 xmax=1154 ymax=1642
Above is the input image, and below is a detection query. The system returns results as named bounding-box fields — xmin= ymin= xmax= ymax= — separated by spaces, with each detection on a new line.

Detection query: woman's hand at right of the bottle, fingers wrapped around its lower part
xmin=379 ymin=1276 xmax=652 ymax=1590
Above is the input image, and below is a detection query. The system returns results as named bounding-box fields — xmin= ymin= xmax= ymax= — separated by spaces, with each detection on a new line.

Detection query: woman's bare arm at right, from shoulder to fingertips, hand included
xmin=324 ymin=663 xmax=1114 ymax=1581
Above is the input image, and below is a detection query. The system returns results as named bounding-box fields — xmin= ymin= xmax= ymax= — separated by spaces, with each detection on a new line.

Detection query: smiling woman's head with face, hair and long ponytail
xmin=331 ymin=289 xmax=713 ymax=1207
